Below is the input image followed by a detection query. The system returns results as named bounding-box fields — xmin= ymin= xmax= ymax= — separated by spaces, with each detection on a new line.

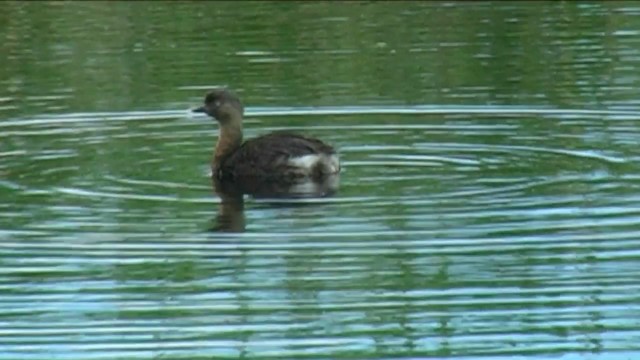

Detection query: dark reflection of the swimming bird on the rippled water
xmin=210 ymin=174 xmax=340 ymax=232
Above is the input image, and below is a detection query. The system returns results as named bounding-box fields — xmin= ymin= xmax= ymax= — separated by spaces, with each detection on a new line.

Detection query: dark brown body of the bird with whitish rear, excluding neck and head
xmin=217 ymin=132 xmax=340 ymax=182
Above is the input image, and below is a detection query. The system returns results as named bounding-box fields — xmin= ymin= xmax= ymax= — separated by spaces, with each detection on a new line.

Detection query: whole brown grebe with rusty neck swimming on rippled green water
xmin=192 ymin=88 xmax=341 ymax=184
